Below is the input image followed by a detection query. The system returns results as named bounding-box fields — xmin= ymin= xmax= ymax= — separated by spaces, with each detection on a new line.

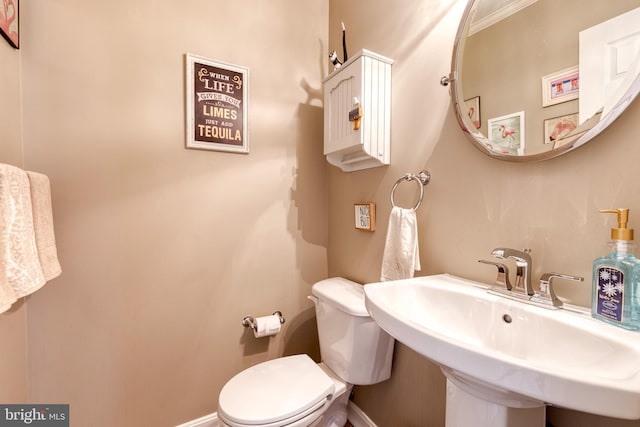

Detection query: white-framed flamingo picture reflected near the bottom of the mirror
xmin=487 ymin=111 xmax=525 ymax=155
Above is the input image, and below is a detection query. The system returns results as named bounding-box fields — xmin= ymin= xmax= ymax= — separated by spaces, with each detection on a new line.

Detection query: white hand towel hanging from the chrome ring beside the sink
xmin=380 ymin=206 xmax=420 ymax=281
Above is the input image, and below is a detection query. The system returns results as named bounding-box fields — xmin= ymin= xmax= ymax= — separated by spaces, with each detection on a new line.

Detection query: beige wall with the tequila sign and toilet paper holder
xmin=18 ymin=0 xmax=328 ymax=427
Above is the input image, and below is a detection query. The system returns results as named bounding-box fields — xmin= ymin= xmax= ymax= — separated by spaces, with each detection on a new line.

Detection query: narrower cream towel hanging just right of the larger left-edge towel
xmin=27 ymin=171 xmax=62 ymax=281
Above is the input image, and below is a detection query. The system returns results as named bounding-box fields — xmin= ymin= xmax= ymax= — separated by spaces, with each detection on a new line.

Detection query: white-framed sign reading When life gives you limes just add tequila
xmin=186 ymin=53 xmax=249 ymax=154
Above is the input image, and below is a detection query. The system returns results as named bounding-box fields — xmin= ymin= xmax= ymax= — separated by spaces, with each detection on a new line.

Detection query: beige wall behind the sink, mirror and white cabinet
xmin=329 ymin=0 xmax=640 ymax=427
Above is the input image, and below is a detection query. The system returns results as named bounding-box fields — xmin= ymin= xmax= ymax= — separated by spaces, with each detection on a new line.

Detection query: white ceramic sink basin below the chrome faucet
xmin=364 ymin=274 xmax=640 ymax=419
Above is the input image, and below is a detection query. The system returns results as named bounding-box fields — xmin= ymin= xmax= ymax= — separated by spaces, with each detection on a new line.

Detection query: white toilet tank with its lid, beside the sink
xmin=311 ymin=277 xmax=394 ymax=385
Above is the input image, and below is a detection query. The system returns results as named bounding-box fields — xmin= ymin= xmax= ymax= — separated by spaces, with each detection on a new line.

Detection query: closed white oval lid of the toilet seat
xmin=218 ymin=354 xmax=334 ymax=425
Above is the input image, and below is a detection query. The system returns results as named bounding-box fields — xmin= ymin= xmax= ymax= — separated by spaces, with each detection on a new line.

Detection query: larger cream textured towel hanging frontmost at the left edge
xmin=0 ymin=164 xmax=45 ymax=312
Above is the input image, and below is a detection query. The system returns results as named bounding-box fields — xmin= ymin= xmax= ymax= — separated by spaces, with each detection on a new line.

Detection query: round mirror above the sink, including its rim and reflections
xmin=448 ymin=0 xmax=640 ymax=161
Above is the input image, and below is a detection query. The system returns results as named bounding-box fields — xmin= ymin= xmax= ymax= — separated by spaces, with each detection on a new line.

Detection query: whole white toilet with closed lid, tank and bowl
xmin=218 ymin=277 xmax=394 ymax=427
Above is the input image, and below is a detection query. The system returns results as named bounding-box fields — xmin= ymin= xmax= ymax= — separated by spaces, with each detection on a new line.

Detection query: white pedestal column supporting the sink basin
xmin=442 ymin=368 xmax=546 ymax=427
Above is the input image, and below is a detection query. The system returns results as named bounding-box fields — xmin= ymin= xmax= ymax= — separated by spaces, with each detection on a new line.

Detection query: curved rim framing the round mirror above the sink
xmin=448 ymin=0 xmax=640 ymax=162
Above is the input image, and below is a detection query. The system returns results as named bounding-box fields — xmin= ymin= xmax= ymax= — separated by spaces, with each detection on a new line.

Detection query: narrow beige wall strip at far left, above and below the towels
xmin=0 ymin=29 xmax=27 ymax=403
